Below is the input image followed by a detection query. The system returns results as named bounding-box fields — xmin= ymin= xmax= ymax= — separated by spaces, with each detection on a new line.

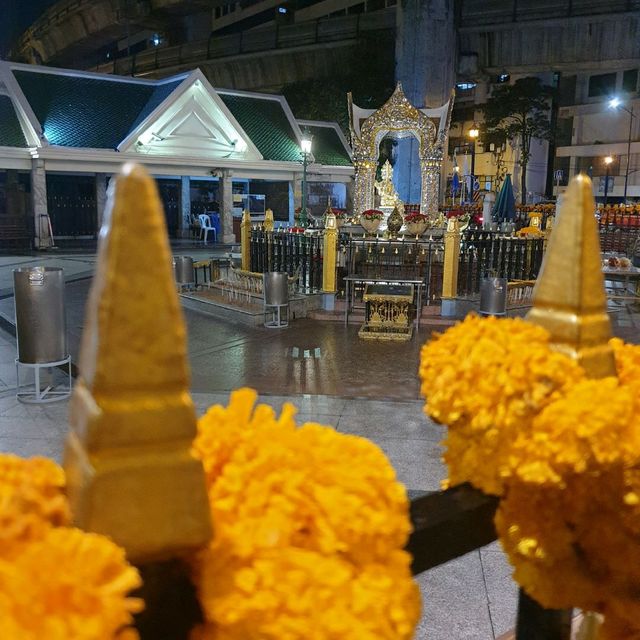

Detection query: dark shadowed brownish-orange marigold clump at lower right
xmin=496 ymin=470 xmax=640 ymax=638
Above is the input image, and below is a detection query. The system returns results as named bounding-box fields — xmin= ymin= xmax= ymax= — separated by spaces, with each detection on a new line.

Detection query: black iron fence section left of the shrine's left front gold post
xmin=249 ymin=229 xmax=323 ymax=294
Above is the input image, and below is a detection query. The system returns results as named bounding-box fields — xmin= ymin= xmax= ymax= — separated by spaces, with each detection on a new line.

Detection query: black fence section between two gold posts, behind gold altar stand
xmin=342 ymin=238 xmax=444 ymax=304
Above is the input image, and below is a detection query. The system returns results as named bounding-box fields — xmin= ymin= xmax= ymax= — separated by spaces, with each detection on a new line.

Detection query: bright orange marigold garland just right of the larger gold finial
xmin=193 ymin=389 xmax=420 ymax=640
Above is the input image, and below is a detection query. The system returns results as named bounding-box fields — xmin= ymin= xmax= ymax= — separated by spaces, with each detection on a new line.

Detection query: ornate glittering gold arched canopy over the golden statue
xmin=347 ymin=82 xmax=453 ymax=219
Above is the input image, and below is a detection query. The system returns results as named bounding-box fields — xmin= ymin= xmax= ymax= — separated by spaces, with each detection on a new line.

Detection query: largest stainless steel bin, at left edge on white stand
xmin=13 ymin=267 xmax=69 ymax=364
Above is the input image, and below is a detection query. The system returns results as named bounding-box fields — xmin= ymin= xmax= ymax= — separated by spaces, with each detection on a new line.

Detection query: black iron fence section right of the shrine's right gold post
xmin=458 ymin=230 xmax=545 ymax=296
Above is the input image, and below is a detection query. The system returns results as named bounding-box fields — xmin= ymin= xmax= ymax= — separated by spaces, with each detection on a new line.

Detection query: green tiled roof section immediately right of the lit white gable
xmin=219 ymin=92 xmax=301 ymax=162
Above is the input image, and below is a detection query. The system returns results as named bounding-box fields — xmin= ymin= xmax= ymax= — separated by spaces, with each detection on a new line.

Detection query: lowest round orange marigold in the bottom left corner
xmin=0 ymin=528 xmax=142 ymax=640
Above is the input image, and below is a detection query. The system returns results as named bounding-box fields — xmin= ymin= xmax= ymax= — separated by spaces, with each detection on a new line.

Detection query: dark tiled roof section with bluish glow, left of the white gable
xmin=13 ymin=70 xmax=180 ymax=149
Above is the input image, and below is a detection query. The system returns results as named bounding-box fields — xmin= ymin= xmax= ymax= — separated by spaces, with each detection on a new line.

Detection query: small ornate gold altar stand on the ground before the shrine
xmin=358 ymin=284 xmax=413 ymax=341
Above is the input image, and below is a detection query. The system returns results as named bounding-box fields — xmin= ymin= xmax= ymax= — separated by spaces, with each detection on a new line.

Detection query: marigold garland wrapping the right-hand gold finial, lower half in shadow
xmin=420 ymin=316 xmax=640 ymax=640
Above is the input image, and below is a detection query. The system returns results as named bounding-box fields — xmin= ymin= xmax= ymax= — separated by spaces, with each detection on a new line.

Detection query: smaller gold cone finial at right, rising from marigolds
xmin=527 ymin=175 xmax=616 ymax=378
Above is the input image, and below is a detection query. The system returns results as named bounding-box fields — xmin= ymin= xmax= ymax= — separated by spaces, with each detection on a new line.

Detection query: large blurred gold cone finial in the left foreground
xmin=65 ymin=165 xmax=211 ymax=562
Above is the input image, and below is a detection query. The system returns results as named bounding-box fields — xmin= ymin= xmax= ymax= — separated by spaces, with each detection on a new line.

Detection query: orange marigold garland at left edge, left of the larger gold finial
xmin=0 ymin=454 xmax=142 ymax=640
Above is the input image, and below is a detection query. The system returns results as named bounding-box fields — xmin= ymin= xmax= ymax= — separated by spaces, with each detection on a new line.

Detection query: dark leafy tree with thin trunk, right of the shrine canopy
xmin=481 ymin=78 xmax=554 ymax=204
